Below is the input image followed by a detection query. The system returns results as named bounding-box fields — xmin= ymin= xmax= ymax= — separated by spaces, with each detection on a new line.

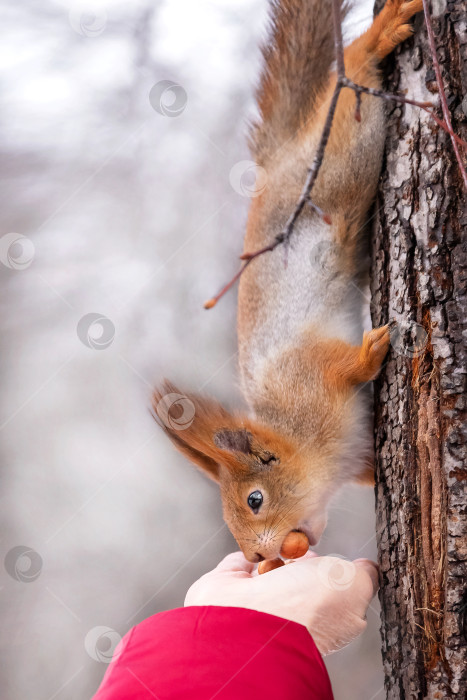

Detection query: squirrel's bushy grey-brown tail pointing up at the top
xmin=250 ymin=0 xmax=346 ymax=163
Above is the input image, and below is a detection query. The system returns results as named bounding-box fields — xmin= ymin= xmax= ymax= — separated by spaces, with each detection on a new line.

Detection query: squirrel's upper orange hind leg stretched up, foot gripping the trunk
xmin=304 ymin=0 xmax=422 ymax=215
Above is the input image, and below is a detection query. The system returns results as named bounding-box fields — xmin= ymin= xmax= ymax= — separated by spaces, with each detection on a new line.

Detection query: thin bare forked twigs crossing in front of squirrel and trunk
xmin=204 ymin=0 xmax=467 ymax=309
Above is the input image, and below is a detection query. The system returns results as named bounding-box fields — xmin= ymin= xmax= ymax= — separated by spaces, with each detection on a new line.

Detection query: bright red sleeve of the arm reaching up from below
xmin=94 ymin=606 xmax=333 ymax=700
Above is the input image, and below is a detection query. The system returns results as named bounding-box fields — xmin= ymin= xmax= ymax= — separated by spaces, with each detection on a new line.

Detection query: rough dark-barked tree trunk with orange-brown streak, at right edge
xmin=371 ymin=0 xmax=467 ymax=700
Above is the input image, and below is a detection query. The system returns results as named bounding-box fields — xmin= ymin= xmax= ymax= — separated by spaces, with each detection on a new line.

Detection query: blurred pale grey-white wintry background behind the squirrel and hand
xmin=0 ymin=0 xmax=383 ymax=700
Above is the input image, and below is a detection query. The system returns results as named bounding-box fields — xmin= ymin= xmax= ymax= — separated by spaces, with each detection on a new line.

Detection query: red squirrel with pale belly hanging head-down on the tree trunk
xmin=153 ymin=0 xmax=422 ymax=562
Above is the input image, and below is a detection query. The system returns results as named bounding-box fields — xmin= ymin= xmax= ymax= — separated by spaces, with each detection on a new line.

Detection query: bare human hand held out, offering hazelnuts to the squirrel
xmin=185 ymin=552 xmax=378 ymax=655
